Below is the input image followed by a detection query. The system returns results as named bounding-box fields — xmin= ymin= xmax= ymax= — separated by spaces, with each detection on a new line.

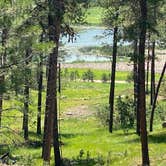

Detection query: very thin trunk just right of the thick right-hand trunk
xmin=146 ymin=35 xmax=150 ymax=94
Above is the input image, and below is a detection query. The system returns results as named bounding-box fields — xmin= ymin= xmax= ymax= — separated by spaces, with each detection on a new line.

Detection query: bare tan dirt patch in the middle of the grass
xmin=64 ymin=105 xmax=93 ymax=118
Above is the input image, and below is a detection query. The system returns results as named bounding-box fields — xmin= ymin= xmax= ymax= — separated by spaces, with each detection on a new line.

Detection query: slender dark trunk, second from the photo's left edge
xmin=23 ymin=49 xmax=30 ymax=140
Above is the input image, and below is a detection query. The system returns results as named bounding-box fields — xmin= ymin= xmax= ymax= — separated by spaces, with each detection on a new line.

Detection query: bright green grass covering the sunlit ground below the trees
xmin=0 ymin=69 xmax=166 ymax=166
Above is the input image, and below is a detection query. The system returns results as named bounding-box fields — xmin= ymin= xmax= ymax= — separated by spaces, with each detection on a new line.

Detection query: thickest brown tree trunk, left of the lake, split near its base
xmin=43 ymin=0 xmax=63 ymax=166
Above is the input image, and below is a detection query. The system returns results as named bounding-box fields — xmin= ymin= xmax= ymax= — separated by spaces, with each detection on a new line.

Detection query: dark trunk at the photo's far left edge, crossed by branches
xmin=0 ymin=29 xmax=8 ymax=127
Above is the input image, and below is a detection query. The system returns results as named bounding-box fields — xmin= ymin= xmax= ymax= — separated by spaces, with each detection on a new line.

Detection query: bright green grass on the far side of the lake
xmin=85 ymin=7 xmax=103 ymax=25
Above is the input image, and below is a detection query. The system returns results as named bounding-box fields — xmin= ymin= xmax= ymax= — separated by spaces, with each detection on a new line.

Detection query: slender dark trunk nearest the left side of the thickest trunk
xmin=37 ymin=56 xmax=43 ymax=135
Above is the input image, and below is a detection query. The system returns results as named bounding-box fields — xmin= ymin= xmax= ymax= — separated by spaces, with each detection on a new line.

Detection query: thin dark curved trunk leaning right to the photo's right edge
xmin=150 ymin=62 xmax=166 ymax=131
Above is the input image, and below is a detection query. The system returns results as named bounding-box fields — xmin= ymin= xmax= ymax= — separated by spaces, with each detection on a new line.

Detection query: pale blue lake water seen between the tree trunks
xmin=62 ymin=28 xmax=113 ymax=62
